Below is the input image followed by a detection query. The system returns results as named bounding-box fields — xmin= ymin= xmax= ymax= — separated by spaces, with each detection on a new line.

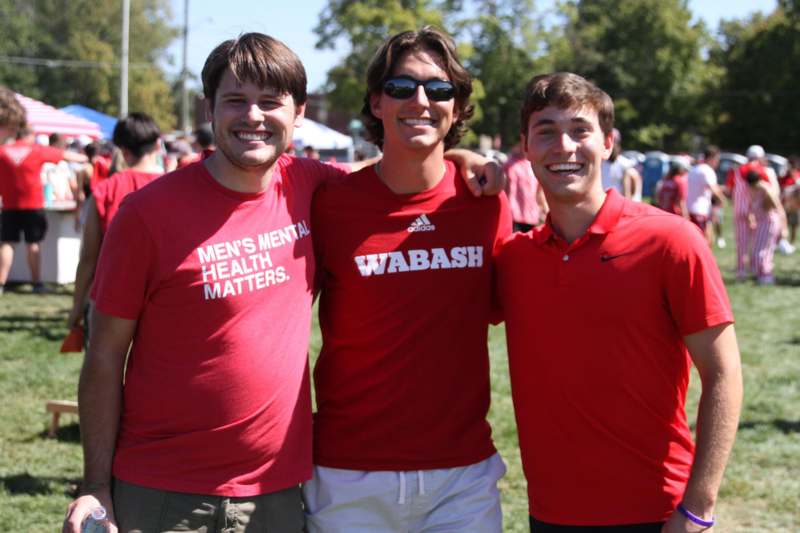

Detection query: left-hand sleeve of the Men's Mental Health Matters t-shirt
xmin=92 ymin=203 xmax=156 ymax=320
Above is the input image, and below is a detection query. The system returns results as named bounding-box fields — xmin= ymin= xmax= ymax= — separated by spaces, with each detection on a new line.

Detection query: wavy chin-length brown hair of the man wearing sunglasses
xmin=361 ymin=26 xmax=474 ymax=148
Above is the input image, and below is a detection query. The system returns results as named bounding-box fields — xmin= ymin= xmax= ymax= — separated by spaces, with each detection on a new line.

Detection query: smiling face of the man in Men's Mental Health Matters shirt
xmin=210 ymin=70 xmax=305 ymax=173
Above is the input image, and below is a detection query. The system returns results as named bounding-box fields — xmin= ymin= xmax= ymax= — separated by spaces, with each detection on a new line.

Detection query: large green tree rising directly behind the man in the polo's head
xmin=555 ymin=0 xmax=719 ymax=150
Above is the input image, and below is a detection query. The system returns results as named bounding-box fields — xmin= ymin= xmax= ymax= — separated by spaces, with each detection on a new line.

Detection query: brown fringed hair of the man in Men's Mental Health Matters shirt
xmin=202 ymin=33 xmax=308 ymax=107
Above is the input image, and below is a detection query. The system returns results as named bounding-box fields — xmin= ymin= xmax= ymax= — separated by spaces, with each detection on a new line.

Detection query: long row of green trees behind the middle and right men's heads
xmin=316 ymin=0 xmax=788 ymax=152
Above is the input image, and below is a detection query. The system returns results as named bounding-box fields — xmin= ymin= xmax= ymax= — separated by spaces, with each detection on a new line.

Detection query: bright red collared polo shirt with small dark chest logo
xmin=497 ymin=191 xmax=733 ymax=525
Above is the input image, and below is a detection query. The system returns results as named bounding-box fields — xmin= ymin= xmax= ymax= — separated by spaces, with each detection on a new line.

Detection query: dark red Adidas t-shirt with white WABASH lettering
xmin=312 ymin=162 xmax=511 ymax=470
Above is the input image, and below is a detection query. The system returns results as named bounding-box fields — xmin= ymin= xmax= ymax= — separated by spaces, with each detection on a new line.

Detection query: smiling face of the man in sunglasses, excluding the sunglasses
xmin=370 ymin=50 xmax=458 ymax=157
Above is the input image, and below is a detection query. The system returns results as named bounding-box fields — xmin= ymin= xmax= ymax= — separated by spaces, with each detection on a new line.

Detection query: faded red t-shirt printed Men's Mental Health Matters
xmin=92 ymin=156 xmax=341 ymax=497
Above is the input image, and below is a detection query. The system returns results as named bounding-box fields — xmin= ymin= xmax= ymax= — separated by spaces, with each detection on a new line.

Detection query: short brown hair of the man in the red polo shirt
xmin=519 ymin=72 xmax=614 ymax=137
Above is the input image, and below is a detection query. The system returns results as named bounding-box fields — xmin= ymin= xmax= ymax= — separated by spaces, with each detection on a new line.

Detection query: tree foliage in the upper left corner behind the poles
xmin=0 ymin=0 xmax=177 ymax=129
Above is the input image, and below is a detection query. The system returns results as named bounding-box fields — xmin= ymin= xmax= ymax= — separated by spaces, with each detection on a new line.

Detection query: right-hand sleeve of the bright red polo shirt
xmin=662 ymin=220 xmax=733 ymax=336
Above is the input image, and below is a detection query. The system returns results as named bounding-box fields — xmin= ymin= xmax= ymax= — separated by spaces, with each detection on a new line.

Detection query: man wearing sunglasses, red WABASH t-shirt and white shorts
xmin=304 ymin=28 xmax=511 ymax=533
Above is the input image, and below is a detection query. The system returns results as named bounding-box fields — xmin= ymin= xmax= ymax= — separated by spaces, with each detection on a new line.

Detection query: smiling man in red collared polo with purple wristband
xmin=498 ymin=73 xmax=742 ymax=533
